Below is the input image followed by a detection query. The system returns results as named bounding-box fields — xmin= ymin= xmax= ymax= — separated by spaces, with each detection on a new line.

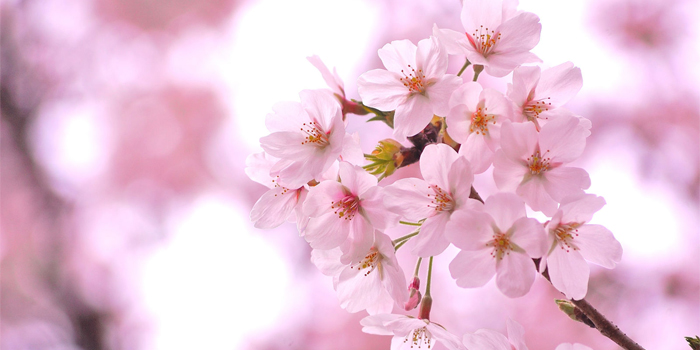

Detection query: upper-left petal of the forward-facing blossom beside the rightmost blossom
xmin=445 ymin=209 xmax=493 ymax=250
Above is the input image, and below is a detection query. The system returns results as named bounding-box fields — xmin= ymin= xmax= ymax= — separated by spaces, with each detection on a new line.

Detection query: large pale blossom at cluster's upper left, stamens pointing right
xmin=260 ymin=90 xmax=345 ymax=187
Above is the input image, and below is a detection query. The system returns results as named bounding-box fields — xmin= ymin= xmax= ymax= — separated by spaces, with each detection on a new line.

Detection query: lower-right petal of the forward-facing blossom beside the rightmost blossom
xmin=496 ymin=252 xmax=535 ymax=298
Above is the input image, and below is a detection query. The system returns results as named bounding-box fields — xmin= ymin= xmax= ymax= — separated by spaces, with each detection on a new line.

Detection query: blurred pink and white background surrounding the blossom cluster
xmin=0 ymin=0 xmax=700 ymax=350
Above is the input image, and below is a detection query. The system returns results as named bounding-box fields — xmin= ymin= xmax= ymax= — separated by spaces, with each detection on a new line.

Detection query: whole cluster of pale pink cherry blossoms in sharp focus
xmin=246 ymin=0 xmax=622 ymax=349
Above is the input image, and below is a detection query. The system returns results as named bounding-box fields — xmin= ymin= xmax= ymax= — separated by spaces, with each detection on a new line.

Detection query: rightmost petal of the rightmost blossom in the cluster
xmin=575 ymin=225 xmax=622 ymax=269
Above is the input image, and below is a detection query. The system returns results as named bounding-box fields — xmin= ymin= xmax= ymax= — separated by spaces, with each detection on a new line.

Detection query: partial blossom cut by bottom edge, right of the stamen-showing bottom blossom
xmin=463 ymin=319 xmax=528 ymax=350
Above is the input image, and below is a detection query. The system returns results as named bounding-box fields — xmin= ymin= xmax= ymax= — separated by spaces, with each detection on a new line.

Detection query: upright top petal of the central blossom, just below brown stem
xmin=420 ymin=143 xmax=459 ymax=191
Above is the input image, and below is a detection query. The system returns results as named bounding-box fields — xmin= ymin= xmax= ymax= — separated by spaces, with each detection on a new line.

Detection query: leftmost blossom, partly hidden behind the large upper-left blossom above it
xmin=245 ymin=152 xmax=308 ymax=229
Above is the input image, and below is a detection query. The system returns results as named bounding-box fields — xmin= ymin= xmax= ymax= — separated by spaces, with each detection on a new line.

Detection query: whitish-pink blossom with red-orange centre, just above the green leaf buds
xmin=357 ymin=37 xmax=462 ymax=138
